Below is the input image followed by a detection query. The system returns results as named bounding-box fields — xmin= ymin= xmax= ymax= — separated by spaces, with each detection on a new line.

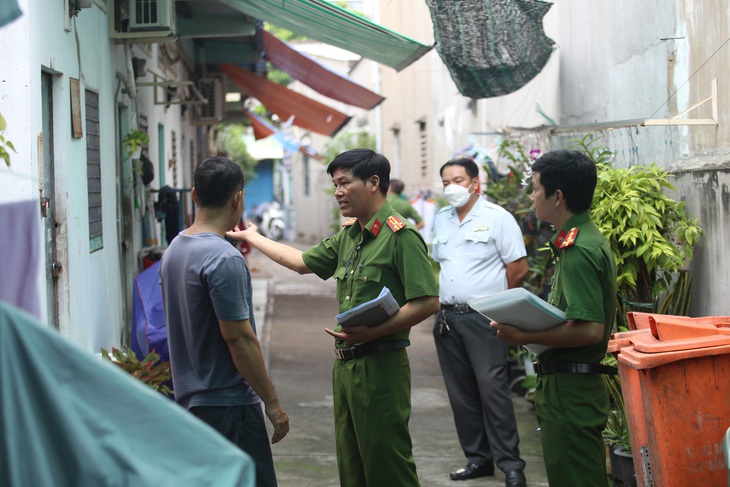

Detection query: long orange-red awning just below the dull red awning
xmin=219 ymin=64 xmax=350 ymax=137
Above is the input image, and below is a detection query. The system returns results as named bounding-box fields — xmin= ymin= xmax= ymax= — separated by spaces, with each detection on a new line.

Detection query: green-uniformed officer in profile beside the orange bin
xmin=491 ymin=151 xmax=616 ymax=487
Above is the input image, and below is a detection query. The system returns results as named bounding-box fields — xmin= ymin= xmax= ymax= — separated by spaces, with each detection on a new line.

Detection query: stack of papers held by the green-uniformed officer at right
xmin=467 ymin=287 xmax=565 ymax=355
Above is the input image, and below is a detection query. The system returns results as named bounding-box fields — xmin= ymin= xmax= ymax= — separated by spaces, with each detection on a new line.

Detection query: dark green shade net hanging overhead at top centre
xmin=429 ymin=0 xmax=554 ymax=98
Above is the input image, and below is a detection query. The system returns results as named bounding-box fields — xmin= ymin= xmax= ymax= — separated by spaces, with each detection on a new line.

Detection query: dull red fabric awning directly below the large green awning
xmin=263 ymin=31 xmax=385 ymax=110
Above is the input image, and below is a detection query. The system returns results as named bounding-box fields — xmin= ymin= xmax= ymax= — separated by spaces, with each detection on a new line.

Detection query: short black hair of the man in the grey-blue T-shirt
xmin=193 ymin=156 xmax=245 ymax=208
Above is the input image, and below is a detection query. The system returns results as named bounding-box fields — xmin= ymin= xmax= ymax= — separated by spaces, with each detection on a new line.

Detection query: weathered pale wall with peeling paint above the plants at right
xmin=555 ymin=0 xmax=730 ymax=315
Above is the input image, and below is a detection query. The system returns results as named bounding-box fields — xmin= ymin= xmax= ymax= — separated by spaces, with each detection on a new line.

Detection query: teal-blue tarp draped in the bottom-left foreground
xmin=0 ymin=302 xmax=255 ymax=487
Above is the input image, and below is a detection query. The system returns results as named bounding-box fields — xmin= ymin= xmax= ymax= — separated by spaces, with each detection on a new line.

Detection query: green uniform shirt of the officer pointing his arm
xmin=302 ymin=202 xmax=438 ymax=346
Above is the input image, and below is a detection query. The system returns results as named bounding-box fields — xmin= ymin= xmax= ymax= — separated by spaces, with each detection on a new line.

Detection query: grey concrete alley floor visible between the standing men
xmin=248 ymin=248 xmax=548 ymax=487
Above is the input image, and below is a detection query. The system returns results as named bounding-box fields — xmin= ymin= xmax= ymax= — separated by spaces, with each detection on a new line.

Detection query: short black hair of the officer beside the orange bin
xmin=532 ymin=150 xmax=598 ymax=214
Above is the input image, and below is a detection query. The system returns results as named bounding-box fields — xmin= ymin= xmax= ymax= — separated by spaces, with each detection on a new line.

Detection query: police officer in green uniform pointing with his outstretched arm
xmin=228 ymin=149 xmax=439 ymax=487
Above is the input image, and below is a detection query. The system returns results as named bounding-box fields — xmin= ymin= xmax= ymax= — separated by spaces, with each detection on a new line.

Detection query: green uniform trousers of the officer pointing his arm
xmin=332 ymin=349 xmax=419 ymax=487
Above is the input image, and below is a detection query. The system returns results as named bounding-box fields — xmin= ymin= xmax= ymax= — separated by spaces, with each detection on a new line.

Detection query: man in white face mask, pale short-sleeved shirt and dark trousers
xmin=432 ymin=159 xmax=527 ymax=487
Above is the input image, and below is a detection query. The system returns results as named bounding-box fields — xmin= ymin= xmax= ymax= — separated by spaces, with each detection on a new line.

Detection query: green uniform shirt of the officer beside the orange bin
xmin=540 ymin=212 xmax=616 ymax=363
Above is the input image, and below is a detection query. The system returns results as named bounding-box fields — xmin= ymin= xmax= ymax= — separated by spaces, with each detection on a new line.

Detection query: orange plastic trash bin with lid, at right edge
xmin=614 ymin=314 xmax=730 ymax=486
